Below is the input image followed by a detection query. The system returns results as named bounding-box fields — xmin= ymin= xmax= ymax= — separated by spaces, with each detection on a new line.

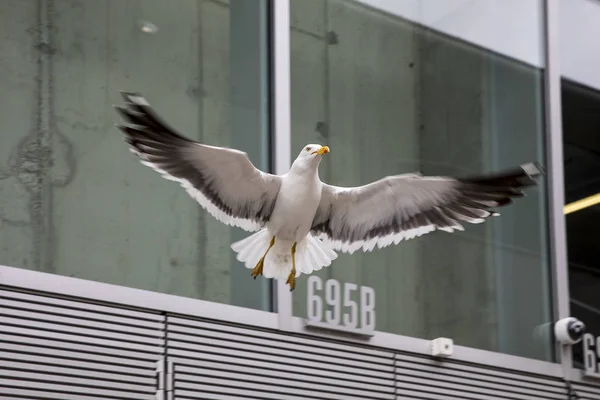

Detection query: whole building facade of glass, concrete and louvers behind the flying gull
xmin=0 ymin=0 xmax=600 ymax=400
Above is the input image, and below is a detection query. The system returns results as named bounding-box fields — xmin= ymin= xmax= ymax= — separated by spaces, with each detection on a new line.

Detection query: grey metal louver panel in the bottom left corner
xmin=0 ymin=290 xmax=164 ymax=400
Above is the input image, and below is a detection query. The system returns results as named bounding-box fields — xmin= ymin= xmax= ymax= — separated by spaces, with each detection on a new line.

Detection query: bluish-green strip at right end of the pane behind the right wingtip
xmin=484 ymin=56 xmax=552 ymax=359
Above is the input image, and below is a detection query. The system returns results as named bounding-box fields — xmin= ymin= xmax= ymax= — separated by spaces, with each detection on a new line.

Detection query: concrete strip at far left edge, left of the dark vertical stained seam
xmin=0 ymin=0 xmax=39 ymax=268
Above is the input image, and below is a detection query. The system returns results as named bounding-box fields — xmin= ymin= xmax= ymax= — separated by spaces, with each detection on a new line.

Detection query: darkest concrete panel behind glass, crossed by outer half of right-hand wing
xmin=417 ymin=30 xmax=498 ymax=349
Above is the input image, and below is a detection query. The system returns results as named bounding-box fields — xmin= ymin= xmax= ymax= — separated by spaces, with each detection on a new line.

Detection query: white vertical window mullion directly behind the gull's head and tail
xmin=271 ymin=0 xmax=292 ymax=331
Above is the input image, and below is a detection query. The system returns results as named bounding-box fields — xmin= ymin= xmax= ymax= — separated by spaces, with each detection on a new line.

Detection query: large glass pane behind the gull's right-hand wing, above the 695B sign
xmin=290 ymin=0 xmax=553 ymax=360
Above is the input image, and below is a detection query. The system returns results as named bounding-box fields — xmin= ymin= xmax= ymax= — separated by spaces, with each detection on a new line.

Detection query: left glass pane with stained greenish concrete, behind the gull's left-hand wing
xmin=0 ymin=0 xmax=271 ymax=309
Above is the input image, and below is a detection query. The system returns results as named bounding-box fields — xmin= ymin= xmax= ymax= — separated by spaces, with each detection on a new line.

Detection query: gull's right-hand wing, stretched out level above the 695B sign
xmin=311 ymin=164 xmax=541 ymax=253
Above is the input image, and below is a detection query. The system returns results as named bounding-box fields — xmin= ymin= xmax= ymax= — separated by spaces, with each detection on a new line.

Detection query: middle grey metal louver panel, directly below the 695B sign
xmin=167 ymin=316 xmax=396 ymax=400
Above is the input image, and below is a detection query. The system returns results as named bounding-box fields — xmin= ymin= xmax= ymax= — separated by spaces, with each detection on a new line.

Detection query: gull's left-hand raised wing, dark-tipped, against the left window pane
xmin=115 ymin=92 xmax=281 ymax=231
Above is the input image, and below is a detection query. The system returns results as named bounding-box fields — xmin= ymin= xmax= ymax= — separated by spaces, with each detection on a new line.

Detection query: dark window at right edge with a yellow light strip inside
xmin=562 ymin=80 xmax=600 ymax=378
